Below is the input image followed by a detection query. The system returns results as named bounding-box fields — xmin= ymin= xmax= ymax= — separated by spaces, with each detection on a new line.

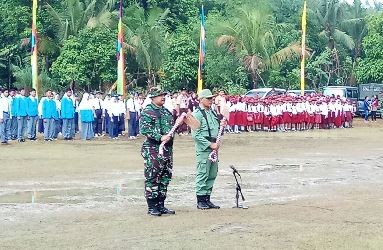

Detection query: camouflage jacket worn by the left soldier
xmin=139 ymin=104 xmax=173 ymax=151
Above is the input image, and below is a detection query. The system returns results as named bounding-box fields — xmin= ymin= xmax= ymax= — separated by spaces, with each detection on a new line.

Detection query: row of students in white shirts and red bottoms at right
xmin=226 ymin=96 xmax=356 ymax=133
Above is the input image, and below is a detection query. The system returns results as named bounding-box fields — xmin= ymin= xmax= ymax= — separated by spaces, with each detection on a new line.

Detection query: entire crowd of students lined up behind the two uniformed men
xmin=0 ymin=88 xmax=360 ymax=144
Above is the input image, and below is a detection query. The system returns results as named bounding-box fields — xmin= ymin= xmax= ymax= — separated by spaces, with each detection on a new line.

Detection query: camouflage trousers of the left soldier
xmin=141 ymin=147 xmax=173 ymax=199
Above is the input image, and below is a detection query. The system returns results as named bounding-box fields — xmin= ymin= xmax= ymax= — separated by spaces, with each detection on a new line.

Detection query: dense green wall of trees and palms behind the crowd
xmin=0 ymin=0 xmax=383 ymax=94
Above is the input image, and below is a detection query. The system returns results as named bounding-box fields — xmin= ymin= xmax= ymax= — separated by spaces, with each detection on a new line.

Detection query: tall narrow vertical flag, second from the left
xmin=117 ymin=0 xmax=126 ymax=97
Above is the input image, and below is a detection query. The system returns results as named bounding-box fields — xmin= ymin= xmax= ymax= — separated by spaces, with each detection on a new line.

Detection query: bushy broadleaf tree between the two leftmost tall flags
xmin=52 ymin=28 xmax=117 ymax=90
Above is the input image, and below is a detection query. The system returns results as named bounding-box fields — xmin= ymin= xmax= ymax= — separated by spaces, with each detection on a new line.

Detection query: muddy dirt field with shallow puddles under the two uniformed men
xmin=0 ymin=120 xmax=383 ymax=249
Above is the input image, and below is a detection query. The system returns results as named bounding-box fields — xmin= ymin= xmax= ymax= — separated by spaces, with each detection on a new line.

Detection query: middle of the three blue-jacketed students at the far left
xmin=13 ymin=88 xmax=28 ymax=142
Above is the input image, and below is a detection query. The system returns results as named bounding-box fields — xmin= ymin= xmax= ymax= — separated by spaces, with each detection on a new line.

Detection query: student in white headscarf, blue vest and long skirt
xmin=78 ymin=93 xmax=94 ymax=140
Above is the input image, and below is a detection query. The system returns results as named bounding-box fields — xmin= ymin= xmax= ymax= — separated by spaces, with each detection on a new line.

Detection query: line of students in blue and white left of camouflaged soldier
xmin=0 ymin=89 xmax=143 ymax=144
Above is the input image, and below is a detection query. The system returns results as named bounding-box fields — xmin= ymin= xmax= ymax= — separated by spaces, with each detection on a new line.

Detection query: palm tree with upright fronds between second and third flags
xmin=123 ymin=6 xmax=169 ymax=87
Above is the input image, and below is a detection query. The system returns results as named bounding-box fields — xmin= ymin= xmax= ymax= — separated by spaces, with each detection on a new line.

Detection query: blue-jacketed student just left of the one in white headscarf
xmin=61 ymin=89 xmax=75 ymax=140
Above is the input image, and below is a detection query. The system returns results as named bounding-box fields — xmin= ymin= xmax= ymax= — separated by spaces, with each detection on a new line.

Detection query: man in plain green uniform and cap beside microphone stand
xmin=192 ymin=89 xmax=225 ymax=209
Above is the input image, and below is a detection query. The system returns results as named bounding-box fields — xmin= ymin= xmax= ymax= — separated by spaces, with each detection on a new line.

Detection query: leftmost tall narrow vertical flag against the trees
xmin=31 ymin=0 xmax=40 ymax=96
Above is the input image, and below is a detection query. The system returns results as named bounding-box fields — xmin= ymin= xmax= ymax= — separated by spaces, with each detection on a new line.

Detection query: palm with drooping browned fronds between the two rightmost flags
xmin=217 ymin=8 xmax=301 ymax=88
